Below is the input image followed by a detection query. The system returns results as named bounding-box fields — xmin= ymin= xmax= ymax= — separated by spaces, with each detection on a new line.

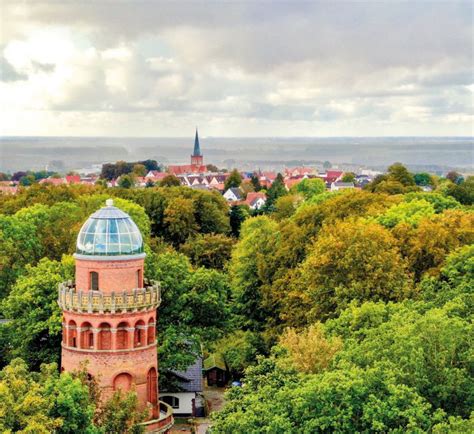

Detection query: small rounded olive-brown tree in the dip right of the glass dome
xmin=180 ymin=234 xmax=235 ymax=270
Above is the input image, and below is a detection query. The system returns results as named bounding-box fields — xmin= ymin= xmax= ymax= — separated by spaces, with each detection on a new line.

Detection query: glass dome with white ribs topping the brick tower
xmin=76 ymin=199 xmax=143 ymax=256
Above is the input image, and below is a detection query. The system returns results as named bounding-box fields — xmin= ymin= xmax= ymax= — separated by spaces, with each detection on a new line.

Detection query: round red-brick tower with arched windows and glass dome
xmin=58 ymin=199 xmax=173 ymax=432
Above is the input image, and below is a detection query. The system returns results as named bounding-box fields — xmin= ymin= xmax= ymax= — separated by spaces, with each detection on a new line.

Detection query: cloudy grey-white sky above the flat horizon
xmin=0 ymin=0 xmax=474 ymax=137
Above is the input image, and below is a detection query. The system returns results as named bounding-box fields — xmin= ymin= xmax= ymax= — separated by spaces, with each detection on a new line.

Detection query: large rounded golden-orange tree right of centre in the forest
xmin=295 ymin=221 xmax=409 ymax=319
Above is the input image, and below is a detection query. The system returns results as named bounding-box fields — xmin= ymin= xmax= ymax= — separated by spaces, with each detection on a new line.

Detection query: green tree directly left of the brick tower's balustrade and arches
xmin=1 ymin=257 xmax=74 ymax=369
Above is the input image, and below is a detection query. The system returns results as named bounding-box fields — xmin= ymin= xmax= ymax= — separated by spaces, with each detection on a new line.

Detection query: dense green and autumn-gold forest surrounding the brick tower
xmin=0 ymin=164 xmax=474 ymax=433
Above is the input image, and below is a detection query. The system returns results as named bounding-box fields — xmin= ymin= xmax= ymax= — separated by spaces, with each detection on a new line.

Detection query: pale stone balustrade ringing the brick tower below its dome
xmin=58 ymin=281 xmax=161 ymax=313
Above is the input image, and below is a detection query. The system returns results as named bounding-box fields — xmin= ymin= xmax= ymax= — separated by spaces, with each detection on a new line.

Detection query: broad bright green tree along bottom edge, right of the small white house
xmin=212 ymin=358 xmax=439 ymax=433
